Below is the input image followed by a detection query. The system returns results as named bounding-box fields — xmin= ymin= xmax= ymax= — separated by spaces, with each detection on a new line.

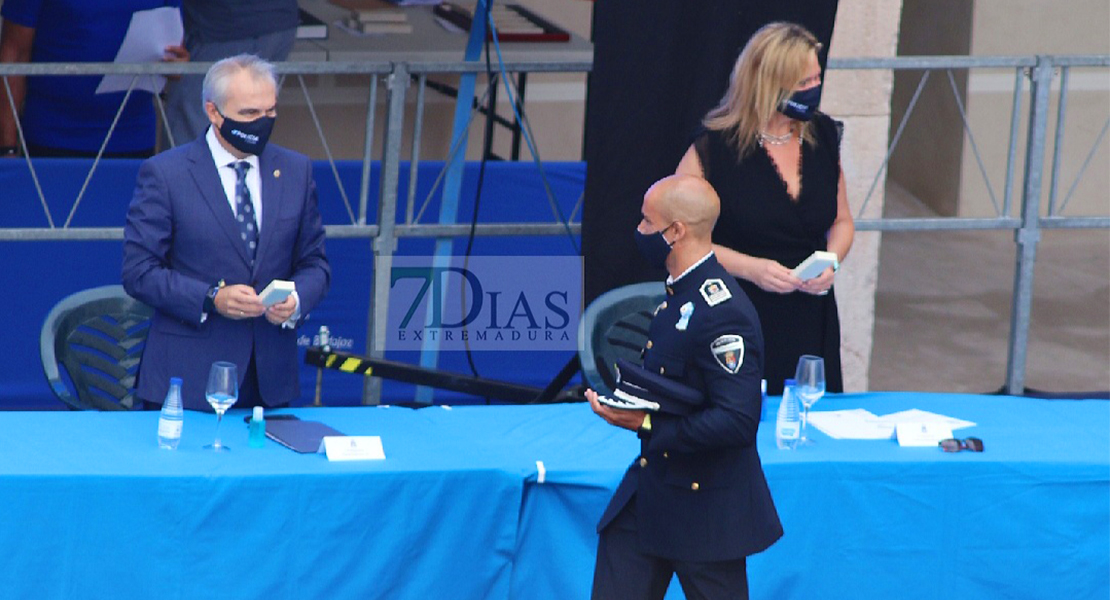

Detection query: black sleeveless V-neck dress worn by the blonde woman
xmin=694 ymin=113 xmax=844 ymax=395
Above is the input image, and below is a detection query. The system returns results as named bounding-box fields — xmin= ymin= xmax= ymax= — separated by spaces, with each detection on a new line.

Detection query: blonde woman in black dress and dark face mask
xmin=677 ymin=23 xmax=856 ymax=395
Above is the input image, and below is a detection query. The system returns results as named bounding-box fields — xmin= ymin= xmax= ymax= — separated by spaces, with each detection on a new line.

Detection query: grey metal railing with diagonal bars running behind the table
xmin=0 ymin=55 xmax=1110 ymax=394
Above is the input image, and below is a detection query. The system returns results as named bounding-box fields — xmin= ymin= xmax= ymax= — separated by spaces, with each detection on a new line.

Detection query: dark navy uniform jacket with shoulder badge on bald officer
xmin=597 ymin=256 xmax=783 ymax=562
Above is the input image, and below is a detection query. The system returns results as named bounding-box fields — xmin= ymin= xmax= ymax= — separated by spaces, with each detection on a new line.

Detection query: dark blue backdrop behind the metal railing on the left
xmin=0 ymin=159 xmax=586 ymax=408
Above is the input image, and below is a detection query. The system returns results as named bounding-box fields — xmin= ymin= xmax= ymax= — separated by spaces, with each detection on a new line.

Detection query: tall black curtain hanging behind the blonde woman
xmin=582 ymin=0 xmax=837 ymax=303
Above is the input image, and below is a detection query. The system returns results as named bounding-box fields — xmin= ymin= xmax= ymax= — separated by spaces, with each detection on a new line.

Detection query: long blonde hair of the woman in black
xmin=703 ymin=22 xmax=821 ymax=156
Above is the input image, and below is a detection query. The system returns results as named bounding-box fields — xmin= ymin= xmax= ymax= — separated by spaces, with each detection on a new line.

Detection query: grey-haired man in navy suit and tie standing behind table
xmin=123 ymin=54 xmax=331 ymax=409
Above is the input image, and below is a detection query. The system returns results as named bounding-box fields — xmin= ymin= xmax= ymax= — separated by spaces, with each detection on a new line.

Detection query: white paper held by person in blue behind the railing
xmin=97 ymin=7 xmax=185 ymax=94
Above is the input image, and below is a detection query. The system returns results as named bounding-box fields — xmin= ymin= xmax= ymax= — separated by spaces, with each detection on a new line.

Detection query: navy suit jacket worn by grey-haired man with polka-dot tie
xmin=122 ymin=136 xmax=331 ymax=409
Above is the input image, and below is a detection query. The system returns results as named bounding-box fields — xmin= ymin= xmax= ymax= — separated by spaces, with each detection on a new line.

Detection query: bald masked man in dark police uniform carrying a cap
xmin=586 ymin=175 xmax=783 ymax=600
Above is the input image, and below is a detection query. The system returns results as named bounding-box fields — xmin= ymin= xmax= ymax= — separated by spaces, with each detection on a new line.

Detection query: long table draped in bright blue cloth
xmin=0 ymin=393 xmax=1110 ymax=600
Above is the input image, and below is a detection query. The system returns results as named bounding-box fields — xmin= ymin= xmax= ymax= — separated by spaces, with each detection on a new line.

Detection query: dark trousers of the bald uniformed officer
xmin=591 ymin=498 xmax=748 ymax=600
